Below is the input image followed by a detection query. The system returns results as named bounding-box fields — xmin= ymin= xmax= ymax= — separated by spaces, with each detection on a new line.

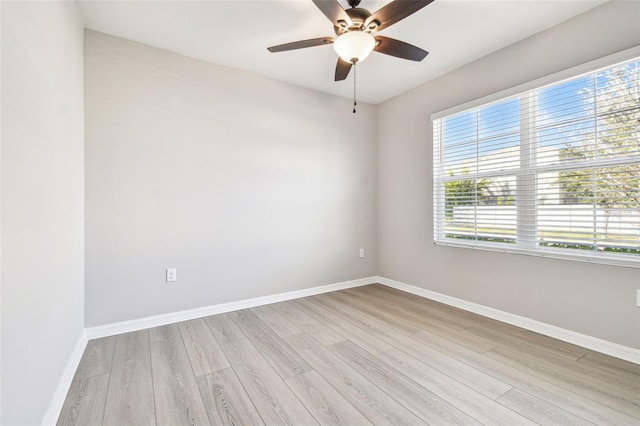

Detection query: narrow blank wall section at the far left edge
xmin=0 ymin=1 xmax=84 ymax=425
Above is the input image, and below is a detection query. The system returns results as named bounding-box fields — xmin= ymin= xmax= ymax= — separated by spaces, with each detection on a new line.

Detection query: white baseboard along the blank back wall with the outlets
xmin=85 ymin=277 xmax=378 ymax=339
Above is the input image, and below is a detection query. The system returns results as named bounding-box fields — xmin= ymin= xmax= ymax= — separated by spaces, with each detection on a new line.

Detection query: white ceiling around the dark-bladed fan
xmin=78 ymin=0 xmax=606 ymax=104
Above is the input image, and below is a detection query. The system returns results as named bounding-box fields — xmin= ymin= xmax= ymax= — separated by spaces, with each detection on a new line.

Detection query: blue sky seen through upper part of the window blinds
xmin=442 ymin=61 xmax=640 ymax=170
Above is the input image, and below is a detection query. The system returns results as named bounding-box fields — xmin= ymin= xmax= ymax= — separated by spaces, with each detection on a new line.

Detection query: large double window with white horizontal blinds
xmin=432 ymin=49 xmax=640 ymax=267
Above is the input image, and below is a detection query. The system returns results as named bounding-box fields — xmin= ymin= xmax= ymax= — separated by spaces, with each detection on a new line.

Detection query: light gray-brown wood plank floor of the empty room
xmin=58 ymin=285 xmax=640 ymax=426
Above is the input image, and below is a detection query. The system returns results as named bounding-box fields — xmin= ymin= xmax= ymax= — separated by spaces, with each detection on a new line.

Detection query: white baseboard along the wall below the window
xmin=374 ymin=277 xmax=640 ymax=364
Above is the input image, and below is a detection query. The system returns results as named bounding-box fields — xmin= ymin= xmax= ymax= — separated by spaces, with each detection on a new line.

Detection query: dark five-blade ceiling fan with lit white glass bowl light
xmin=268 ymin=0 xmax=434 ymax=81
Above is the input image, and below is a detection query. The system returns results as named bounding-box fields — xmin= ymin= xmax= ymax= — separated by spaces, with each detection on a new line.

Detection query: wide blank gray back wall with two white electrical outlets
xmin=85 ymin=31 xmax=377 ymax=327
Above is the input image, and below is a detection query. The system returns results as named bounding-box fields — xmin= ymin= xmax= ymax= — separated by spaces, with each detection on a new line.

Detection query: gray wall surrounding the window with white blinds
xmin=378 ymin=2 xmax=640 ymax=348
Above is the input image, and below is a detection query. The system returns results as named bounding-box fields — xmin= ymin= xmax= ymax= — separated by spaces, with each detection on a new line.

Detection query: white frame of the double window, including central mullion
xmin=431 ymin=46 xmax=640 ymax=268
